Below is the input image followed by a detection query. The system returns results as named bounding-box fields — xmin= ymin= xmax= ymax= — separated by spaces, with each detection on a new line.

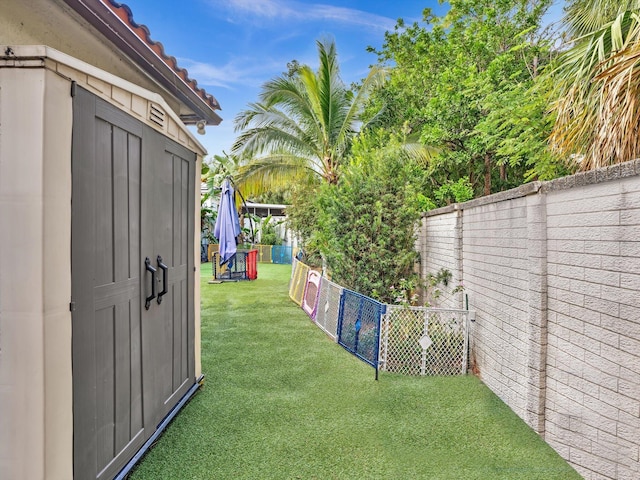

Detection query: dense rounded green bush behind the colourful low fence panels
xmin=313 ymin=133 xmax=424 ymax=302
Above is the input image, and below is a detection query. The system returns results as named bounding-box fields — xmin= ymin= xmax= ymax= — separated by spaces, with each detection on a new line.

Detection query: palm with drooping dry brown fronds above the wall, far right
xmin=550 ymin=0 xmax=640 ymax=170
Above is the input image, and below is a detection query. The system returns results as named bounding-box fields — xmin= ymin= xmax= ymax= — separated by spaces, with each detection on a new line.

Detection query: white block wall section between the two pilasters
xmin=462 ymin=197 xmax=528 ymax=418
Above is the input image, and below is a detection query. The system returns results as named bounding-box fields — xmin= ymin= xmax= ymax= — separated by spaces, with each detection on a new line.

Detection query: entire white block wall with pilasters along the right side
xmin=420 ymin=166 xmax=640 ymax=479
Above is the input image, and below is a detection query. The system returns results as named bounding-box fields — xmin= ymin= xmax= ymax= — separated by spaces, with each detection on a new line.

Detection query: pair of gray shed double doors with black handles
xmin=71 ymin=88 xmax=196 ymax=480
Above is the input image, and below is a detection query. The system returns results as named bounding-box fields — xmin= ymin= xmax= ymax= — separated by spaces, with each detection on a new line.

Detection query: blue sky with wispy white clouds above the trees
xmin=122 ymin=0 xmax=560 ymax=156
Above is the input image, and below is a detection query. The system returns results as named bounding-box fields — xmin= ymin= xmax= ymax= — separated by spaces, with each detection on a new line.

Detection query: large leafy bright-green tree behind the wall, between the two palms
xmin=364 ymin=0 xmax=556 ymax=195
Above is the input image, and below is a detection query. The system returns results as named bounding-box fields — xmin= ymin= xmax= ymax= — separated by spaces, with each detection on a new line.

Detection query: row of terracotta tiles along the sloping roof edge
xmin=101 ymin=0 xmax=220 ymax=110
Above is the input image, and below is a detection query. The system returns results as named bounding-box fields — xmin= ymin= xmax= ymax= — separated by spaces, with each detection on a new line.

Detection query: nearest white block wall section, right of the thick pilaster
xmin=546 ymin=176 xmax=640 ymax=479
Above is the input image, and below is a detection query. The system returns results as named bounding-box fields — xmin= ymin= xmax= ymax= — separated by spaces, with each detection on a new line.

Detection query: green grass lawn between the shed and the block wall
xmin=130 ymin=264 xmax=581 ymax=480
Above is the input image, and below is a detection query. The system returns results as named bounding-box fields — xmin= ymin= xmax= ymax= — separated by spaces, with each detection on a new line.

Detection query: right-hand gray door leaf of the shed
xmin=142 ymin=132 xmax=195 ymax=423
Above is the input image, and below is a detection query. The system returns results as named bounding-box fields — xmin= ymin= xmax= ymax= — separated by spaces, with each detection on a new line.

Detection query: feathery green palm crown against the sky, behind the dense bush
xmin=232 ymin=36 xmax=386 ymax=194
